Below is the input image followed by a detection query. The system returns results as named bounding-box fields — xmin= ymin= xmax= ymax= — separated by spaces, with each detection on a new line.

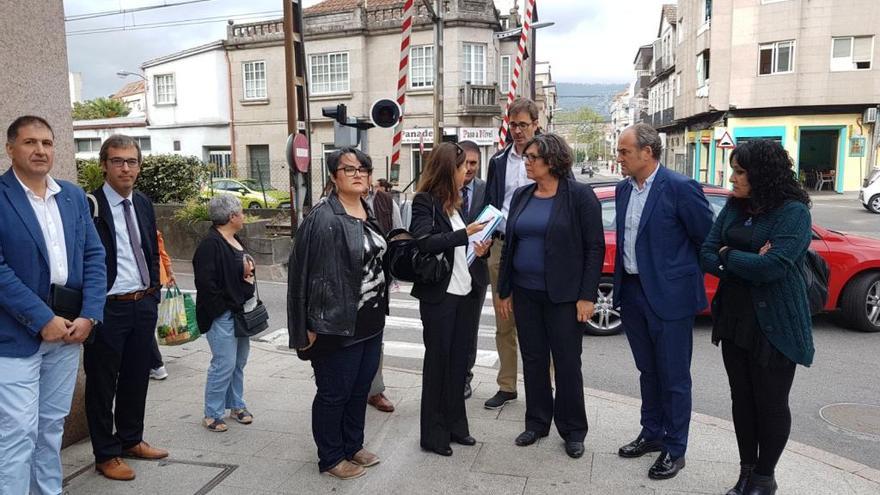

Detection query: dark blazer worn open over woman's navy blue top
xmin=498 ymin=179 xmax=605 ymax=304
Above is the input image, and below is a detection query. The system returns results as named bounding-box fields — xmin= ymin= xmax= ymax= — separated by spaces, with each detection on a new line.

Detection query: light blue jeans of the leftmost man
xmin=0 ymin=342 xmax=80 ymax=495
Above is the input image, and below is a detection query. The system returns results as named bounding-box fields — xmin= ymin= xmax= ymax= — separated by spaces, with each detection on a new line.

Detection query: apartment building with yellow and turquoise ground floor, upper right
xmin=675 ymin=0 xmax=880 ymax=192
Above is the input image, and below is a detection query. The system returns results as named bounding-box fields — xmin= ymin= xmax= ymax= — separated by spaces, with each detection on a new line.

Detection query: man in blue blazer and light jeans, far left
xmin=0 ymin=116 xmax=107 ymax=495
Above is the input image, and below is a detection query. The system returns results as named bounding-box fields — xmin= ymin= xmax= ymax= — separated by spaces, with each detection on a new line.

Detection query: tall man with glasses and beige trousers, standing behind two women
xmin=481 ymin=98 xmax=538 ymax=409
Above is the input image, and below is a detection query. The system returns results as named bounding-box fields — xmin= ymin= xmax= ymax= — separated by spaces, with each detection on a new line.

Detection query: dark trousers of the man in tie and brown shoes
xmin=83 ymin=294 xmax=159 ymax=463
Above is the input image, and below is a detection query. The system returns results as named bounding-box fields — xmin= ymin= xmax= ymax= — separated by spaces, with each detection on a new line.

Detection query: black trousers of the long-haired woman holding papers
xmin=419 ymin=294 xmax=477 ymax=449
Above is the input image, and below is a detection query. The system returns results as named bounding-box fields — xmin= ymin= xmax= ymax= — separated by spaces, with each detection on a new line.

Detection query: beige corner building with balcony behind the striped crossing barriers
xmin=300 ymin=0 xmax=540 ymax=201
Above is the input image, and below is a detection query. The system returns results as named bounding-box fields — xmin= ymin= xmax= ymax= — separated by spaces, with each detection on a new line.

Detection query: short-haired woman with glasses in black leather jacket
xmin=287 ymin=148 xmax=388 ymax=479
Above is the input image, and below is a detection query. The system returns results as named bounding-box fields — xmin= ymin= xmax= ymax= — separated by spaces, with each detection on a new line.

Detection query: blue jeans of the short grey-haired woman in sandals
xmin=205 ymin=311 xmax=251 ymax=419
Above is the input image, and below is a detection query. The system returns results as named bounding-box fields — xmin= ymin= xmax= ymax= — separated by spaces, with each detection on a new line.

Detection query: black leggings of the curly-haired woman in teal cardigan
xmin=721 ymin=340 xmax=795 ymax=476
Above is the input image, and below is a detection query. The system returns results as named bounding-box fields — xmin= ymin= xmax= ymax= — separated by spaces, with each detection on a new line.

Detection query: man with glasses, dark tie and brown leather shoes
xmin=83 ymin=134 xmax=168 ymax=480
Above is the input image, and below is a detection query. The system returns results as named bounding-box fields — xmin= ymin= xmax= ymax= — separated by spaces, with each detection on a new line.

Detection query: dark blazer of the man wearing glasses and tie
xmin=92 ymin=186 xmax=160 ymax=291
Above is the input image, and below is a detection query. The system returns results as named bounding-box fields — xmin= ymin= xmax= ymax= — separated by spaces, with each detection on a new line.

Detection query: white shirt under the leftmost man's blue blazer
xmin=12 ymin=169 xmax=67 ymax=285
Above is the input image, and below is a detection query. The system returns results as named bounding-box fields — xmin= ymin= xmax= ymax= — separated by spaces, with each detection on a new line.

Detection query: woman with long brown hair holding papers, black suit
xmin=410 ymin=143 xmax=490 ymax=456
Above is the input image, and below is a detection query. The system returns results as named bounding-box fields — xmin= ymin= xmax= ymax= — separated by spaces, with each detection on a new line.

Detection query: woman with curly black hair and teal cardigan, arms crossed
xmin=700 ymin=140 xmax=814 ymax=495
